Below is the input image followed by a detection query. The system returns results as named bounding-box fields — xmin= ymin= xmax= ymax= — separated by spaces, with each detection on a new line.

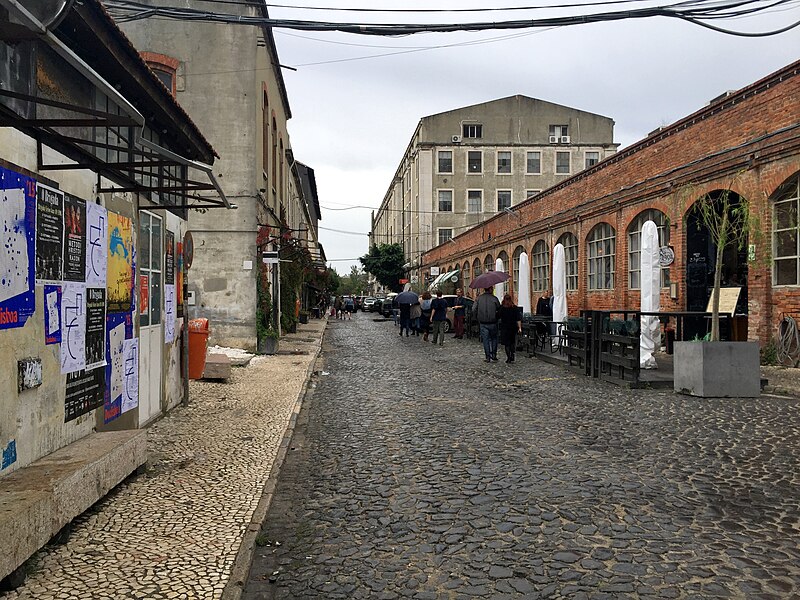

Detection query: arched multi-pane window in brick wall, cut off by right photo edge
xmin=772 ymin=177 xmax=800 ymax=285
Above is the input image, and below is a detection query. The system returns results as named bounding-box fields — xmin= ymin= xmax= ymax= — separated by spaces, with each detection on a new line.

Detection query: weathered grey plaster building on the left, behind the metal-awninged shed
xmin=121 ymin=0 xmax=319 ymax=350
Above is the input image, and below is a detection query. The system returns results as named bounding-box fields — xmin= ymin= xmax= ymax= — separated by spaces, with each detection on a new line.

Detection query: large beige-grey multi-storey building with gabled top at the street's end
xmin=371 ymin=95 xmax=617 ymax=280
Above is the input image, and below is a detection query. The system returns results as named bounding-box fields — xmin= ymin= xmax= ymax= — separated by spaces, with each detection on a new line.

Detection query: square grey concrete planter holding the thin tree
xmin=674 ymin=342 xmax=761 ymax=398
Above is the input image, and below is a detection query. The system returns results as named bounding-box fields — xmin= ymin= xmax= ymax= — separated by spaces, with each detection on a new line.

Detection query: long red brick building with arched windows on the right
xmin=420 ymin=61 xmax=800 ymax=342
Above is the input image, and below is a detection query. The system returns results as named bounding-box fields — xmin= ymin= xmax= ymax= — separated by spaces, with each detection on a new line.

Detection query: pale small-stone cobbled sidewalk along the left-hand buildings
xmin=0 ymin=320 xmax=324 ymax=600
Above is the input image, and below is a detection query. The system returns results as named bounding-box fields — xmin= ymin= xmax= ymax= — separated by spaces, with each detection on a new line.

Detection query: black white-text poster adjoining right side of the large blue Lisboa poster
xmin=36 ymin=184 xmax=64 ymax=282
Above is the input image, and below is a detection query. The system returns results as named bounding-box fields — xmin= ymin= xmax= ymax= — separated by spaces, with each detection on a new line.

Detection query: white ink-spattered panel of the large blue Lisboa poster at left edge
xmin=0 ymin=188 xmax=33 ymax=302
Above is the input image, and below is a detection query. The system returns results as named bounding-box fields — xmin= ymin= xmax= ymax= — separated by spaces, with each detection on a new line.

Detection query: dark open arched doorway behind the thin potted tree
xmin=685 ymin=190 xmax=748 ymax=340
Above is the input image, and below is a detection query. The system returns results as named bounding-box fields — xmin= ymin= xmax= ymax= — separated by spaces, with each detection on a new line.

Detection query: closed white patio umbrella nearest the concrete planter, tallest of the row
xmin=639 ymin=221 xmax=661 ymax=369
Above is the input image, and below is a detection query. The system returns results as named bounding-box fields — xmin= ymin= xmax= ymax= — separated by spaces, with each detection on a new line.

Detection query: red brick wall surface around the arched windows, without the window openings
xmin=422 ymin=61 xmax=800 ymax=342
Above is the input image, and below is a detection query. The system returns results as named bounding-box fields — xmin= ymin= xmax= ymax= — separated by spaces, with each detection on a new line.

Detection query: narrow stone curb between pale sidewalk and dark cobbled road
xmin=221 ymin=318 xmax=328 ymax=600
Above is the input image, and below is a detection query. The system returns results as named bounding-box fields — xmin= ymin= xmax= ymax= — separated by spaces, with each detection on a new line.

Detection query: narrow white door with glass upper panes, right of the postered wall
xmin=138 ymin=211 xmax=164 ymax=426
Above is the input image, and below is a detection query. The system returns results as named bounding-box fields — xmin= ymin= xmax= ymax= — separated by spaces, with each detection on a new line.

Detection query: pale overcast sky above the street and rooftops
xmin=268 ymin=0 xmax=800 ymax=274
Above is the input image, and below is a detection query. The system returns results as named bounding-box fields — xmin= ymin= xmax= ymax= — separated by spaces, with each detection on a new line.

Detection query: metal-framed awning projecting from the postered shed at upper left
xmin=0 ymin=0 xmax=235 ymax=209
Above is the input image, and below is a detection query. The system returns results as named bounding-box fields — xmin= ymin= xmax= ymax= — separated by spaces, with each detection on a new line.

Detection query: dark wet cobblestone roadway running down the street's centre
xmin=244 ymin=313 xmax=800 ymax=600
